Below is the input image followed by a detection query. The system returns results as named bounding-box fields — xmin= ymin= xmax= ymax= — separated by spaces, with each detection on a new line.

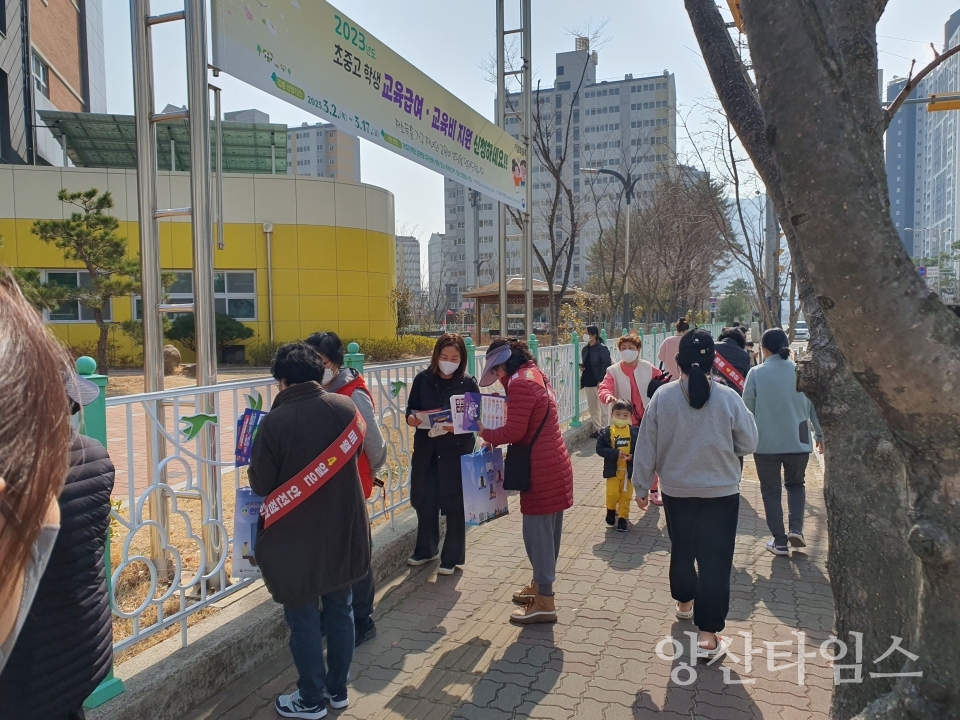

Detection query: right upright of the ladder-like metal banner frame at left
xmin=184 ymin=0 xmax=222 ymax=584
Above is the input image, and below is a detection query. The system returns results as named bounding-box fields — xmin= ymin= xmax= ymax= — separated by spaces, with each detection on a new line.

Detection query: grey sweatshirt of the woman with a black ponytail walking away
xmin=633 ymin=380 xmax=757 ymax=497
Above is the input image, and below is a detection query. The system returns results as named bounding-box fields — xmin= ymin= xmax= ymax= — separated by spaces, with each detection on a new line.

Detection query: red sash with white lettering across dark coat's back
xmin=260 ymin=410 xmax=367 ymax=529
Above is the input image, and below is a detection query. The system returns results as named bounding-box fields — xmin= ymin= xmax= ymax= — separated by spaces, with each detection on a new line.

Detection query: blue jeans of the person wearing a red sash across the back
xmin=283 ymin=588 xmax=354 ymax=705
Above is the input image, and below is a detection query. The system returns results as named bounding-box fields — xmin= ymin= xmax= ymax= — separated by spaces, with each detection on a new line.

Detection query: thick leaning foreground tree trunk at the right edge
xmin=742 ymin=0 xmax=960 ymax=718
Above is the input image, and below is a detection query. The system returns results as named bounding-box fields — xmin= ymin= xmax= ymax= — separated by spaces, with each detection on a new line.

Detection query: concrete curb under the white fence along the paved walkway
xmin=86 ymin=423 xmax=590 ymax=720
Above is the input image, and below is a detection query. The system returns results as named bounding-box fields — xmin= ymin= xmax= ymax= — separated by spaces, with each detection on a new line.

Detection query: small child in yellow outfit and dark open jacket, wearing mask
xmin=597 ymin=400 xmax=639 ymax=532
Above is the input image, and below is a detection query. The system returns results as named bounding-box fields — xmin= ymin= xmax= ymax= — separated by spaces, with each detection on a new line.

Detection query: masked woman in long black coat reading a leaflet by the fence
xmin=407 ymin=333 xmax=480 ymax=575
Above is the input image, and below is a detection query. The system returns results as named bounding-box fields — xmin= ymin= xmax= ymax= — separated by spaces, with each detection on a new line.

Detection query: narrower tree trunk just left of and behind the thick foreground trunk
xmin=686 ymin=0 xmax=918 ymax=720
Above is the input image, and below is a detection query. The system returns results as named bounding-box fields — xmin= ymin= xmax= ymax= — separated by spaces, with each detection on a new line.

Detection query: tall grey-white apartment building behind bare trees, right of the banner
xmin=440 ymin=38 xmax=677 ymax=306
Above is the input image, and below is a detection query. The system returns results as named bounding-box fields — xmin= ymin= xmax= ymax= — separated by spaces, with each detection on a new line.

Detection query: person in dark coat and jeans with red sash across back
xmin=248 ymin=342 xmax=370 ymax=720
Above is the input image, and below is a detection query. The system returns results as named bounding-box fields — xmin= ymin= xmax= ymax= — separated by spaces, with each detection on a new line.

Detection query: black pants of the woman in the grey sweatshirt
xmin=662 ymin=494 xmax=740 ymax=633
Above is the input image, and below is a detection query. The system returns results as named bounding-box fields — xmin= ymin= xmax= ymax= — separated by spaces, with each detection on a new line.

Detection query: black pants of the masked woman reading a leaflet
xmin=411 ymin=457 xmax=467 ymax=567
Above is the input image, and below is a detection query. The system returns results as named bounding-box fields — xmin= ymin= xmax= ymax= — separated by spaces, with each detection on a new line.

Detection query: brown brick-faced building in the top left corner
xmin=0 ymin=0 xmax=107 ymax=165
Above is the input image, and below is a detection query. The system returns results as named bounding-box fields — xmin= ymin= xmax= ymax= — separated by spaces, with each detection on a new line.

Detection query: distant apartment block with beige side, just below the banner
xmin=287 ymin=118 xmax=360 ymax=182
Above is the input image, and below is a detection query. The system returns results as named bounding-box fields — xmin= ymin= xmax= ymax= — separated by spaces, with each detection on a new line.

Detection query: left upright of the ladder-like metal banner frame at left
xmin=130 ymin=0 xmax=170 ymax=578
